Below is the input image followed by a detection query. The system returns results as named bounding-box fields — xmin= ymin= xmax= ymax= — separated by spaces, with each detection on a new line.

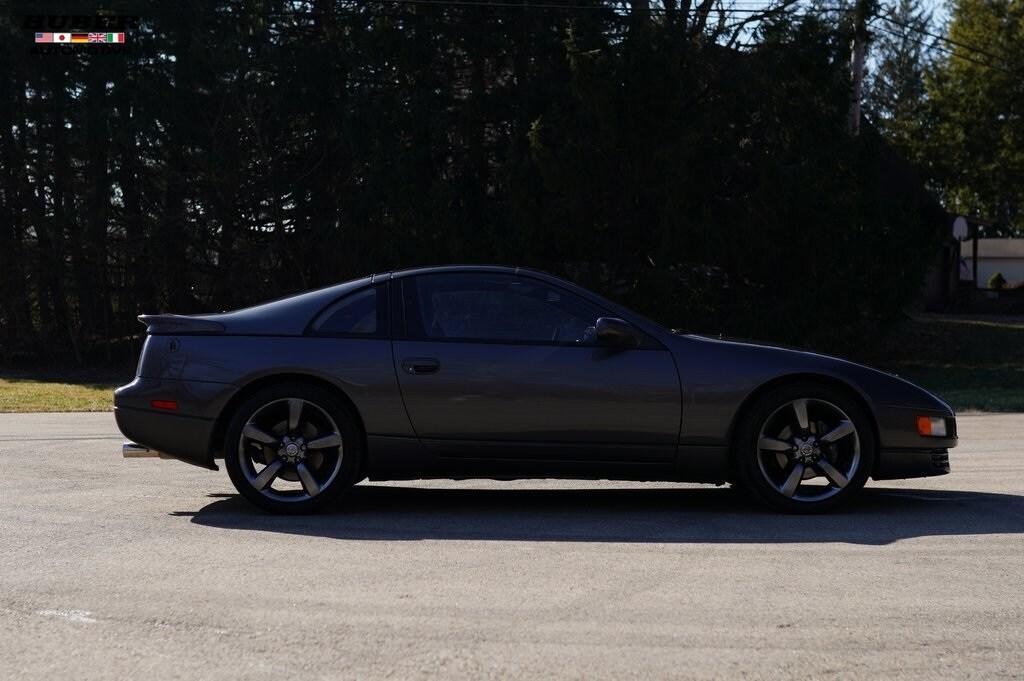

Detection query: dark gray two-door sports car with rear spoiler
xmin=114 ymin=266 xmax=956 ymax=513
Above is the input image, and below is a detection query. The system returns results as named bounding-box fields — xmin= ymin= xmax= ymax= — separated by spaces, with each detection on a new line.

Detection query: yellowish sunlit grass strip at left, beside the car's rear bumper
xmin=0 ymin=370 xmax=131 ymax=414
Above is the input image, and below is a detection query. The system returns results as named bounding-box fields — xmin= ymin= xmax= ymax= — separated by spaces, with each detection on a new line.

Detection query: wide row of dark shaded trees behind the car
xmin=0 ymin=0 xmax=937 ymax=360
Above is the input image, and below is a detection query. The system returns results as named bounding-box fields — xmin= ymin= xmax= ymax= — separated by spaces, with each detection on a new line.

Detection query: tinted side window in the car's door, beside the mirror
xmin=412 ymin=273 xmax=603 ymax=343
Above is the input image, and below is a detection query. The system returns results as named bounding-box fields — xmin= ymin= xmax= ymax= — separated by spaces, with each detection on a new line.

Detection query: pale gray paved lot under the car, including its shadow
xmin=0 ymin=414 xmax=1024 ymax=680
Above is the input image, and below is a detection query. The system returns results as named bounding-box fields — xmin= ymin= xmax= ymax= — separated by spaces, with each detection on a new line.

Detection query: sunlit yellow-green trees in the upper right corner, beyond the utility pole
xmin=870 ymin=0 xmax=1024 ymax=237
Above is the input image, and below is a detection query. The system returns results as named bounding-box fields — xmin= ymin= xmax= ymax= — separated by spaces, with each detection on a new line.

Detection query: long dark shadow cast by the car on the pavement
xmin=173 ymin=484 xmax=1024 ymax=545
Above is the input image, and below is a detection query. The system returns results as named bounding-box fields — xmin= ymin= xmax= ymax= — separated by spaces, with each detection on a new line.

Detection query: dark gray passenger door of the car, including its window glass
xmin=393 ymin=271 xmax=680 ymax=463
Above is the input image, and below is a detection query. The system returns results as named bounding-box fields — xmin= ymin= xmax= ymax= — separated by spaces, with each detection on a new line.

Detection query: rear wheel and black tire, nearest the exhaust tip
xmin=224 ymin=382 xmax=364 ymax=514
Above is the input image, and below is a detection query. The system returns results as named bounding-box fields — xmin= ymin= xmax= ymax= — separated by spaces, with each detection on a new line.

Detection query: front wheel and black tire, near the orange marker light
xmin=733 ymin=382 xmax=878 ymax=513
